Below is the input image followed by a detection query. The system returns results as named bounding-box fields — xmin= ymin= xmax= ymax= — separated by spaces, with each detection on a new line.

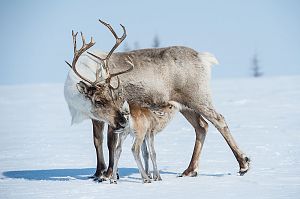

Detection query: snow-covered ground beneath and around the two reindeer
xmin=0 ymin=76 xmax=300 ymax=199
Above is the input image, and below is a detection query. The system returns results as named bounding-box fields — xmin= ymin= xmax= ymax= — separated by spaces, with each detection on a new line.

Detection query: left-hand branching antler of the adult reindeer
xmin=66 ymin=30 xmax=97 ymax=85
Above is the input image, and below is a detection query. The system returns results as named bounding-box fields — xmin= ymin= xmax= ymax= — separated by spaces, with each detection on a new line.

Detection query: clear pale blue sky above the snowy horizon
xmin=0 ymin=0 xmax=300 ymax=84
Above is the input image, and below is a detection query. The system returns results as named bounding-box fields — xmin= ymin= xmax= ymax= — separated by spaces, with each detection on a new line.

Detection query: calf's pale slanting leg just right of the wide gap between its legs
xmin=131 ymin=136 xmax=151 ymax=183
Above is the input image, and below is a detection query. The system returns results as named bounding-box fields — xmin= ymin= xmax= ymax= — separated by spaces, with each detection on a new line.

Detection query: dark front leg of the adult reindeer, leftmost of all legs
xmin=90 ymin=120 xmax=106 ymax=180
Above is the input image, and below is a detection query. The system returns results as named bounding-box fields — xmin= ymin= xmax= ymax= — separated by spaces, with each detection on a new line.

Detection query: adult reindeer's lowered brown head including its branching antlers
xmin=66 ymin=20 xmax=134 ymax=129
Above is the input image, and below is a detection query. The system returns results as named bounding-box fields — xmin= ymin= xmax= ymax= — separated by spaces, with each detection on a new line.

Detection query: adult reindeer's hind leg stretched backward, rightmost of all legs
xmin=199 ymin=106 xmax=250 ymax=175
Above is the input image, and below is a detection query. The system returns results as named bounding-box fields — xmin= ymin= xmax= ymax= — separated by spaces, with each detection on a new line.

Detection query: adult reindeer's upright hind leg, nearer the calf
xmin=180 ymin=109 xmax=208 ymax=177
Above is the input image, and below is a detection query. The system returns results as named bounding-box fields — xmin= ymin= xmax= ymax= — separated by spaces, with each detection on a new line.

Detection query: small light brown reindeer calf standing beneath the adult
xmin=111 ymin=101 xmax=179 ymax=183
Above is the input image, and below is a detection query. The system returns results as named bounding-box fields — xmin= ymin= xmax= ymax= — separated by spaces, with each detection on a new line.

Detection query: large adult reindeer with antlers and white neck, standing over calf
xmin=65 ymin=20 xmax=249 ymax=182
